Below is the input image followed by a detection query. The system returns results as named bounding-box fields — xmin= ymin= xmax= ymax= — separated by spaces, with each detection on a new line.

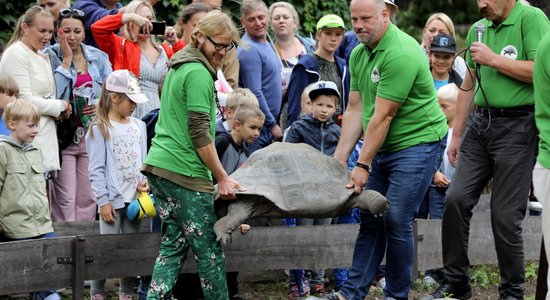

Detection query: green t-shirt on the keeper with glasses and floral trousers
xmin=144 ymin=61 xmax=216 ymax=181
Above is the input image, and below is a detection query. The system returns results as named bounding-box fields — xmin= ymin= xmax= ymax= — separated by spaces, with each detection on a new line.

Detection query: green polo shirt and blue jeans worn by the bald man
xmin=338 ymin=23 xmax=447 ymax=300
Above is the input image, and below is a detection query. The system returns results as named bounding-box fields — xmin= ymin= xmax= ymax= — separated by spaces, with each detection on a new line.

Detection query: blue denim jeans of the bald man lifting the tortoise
xmin=339 ymin=137 xmax=447 ymax=300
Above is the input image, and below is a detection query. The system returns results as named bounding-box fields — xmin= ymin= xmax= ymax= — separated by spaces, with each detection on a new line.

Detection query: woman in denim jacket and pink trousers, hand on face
xmin=44 ymin=8 xmax=112 ymax=221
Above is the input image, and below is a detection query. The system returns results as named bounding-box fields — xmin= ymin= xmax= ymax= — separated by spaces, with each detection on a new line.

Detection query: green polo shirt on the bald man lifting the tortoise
xmin=349 ymin=23 xmax=447 ymax=152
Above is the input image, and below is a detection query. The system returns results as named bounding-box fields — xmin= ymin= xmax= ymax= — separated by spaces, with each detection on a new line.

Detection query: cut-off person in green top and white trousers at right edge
xmin=533 ymin=32 xmax=550 ymax=299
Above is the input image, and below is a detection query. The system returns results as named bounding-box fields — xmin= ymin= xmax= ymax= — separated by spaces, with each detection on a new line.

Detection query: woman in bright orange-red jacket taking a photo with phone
xmin=92 ymin=0 xmax=185 ymax=118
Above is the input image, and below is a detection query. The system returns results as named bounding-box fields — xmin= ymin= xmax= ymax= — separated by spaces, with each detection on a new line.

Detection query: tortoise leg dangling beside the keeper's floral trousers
xmin=214 ymin=200 xmax=254 ymax=244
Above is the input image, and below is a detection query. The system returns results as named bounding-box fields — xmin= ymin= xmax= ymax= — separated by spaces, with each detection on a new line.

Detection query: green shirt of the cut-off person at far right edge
xmin=533 ymin=32 xmax=550 ymax=169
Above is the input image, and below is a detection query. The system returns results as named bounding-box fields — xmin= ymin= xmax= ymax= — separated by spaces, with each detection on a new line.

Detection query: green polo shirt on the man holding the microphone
xmin=466 ymin=1 xmax=550 ymax=108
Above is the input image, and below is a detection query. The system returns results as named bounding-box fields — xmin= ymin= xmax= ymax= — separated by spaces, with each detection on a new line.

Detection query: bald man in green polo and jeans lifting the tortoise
xmin=312 ymin=0 xmax=447 ymax=300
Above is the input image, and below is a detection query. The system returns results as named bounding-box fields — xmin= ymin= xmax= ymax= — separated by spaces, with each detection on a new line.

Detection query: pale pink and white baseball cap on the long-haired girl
xmin=105 ymin=70 xmax=149 ymax=104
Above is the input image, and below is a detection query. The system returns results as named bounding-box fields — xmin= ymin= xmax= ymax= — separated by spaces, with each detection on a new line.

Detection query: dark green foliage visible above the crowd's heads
xmin=0 ymin=0 xmax=550 ymax=48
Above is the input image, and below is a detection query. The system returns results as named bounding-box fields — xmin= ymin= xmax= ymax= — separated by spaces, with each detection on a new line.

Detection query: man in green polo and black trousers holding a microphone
xmin=423 ymin=0 xmax=550 ymax=300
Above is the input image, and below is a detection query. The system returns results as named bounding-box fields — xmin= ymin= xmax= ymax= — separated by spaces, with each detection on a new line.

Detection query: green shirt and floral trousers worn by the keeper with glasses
xmin=143 ymin=45 xmax=228 ymax=300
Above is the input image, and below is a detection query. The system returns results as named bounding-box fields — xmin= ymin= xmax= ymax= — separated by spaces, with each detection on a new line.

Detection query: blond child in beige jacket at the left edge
xmin=0 ymin=99 xmax=61 ymax=300
